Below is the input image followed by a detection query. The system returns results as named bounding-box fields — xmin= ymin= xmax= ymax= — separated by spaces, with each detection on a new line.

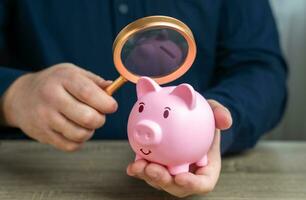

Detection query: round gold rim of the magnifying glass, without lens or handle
xmin=113 ymin=15 xmax=196 ymax=84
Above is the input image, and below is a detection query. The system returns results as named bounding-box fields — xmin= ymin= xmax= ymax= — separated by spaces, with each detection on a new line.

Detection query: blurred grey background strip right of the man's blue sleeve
xmin=265 ymin=0 xmax=306 ymax=140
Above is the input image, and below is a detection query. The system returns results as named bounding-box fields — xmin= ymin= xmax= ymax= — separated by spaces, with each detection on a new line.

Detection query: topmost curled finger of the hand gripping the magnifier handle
xmin=64 ymin=74 xmax=118 ymax=114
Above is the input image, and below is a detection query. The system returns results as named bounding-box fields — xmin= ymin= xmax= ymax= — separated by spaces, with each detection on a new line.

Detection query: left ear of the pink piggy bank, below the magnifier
xmin=136 ymin=77 xmax=160 ymax=99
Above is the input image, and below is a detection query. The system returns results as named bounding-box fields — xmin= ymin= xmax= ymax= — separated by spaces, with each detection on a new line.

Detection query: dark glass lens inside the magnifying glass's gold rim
xmin=121 ymin=28 xmax=188 ymax=77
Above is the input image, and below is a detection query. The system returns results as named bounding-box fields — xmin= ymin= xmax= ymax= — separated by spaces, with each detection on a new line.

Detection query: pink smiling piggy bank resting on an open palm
xmin=128 ymin=77 xmax=215 ymax=175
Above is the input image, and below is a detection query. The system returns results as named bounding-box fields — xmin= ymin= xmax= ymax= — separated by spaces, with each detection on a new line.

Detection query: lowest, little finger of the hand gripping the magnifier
xmin=46 ymin=130 xmax=82 ymax=152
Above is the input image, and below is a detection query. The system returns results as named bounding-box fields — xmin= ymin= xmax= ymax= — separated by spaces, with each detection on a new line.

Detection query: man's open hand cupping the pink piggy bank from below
xmin=127 ymin=100 xmax=232 ymax=197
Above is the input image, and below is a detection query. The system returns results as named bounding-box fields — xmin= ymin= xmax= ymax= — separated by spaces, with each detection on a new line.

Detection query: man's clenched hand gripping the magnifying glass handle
xmin=2 ymin=63 xmax=117 ymax=151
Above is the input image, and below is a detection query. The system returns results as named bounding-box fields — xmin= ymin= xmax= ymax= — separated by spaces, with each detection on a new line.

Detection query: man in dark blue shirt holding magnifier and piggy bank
xmin=0 ymin=0 xmax=287 ymax=197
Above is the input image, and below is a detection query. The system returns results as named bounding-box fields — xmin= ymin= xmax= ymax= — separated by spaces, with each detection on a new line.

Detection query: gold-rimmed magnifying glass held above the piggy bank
xmin=106 ymin=16 xmax=196 ymax=95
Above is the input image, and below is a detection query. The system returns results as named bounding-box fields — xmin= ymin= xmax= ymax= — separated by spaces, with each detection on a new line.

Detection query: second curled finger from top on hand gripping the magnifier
xmin=56 ymin=88 xmax=105 ymax=130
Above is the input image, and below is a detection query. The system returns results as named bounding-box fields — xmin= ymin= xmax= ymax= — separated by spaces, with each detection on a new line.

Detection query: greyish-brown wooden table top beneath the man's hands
xmin=0 ymin=141 xmax=306 ymax=200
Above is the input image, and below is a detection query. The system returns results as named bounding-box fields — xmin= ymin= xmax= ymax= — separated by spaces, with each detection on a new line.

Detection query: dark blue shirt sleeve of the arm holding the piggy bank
xmin=204 ymin=0 xmax=287 ymax=153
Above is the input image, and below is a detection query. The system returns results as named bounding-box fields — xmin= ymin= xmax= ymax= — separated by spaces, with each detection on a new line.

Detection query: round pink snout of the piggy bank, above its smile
xmin=133 ymin=120 xmax=162 ymax=146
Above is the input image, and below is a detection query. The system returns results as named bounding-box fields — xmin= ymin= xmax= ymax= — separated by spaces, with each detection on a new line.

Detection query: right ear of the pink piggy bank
xmin=170 ymin=84 xmax=196 ymax=110
